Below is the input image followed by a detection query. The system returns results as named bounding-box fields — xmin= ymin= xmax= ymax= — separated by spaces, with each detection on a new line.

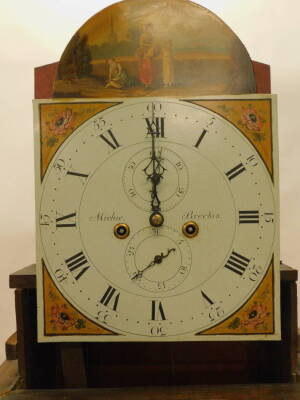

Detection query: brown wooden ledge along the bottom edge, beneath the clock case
xmin=1 ymin=384 xmax=300 ymax=400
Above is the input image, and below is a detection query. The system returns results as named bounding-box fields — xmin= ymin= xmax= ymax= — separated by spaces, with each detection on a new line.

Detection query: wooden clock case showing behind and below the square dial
xmin=5 ymin=62 xmax=297 ymax=389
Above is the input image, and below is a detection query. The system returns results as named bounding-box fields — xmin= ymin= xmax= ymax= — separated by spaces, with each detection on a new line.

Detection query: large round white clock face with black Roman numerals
xmin=39 ymin=99 xmax=277 ymax=340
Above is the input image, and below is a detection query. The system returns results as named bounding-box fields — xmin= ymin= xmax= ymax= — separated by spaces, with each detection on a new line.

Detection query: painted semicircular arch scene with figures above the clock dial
xmin=54 ymin=0 xmax=255 ymax=98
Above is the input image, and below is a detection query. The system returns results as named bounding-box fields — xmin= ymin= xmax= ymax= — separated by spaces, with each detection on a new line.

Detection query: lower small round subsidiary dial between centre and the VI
xmin=125 ymin=226 xmax=192 ymax=293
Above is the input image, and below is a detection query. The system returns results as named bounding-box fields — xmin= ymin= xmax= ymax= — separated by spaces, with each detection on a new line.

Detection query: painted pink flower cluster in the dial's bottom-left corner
xmin=50 ymin=304 xmax=85 ymax=331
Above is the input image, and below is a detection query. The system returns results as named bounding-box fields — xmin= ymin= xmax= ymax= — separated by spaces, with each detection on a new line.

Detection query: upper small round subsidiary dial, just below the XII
xmin=123 ymin=146 xmax=189 ymax=211
